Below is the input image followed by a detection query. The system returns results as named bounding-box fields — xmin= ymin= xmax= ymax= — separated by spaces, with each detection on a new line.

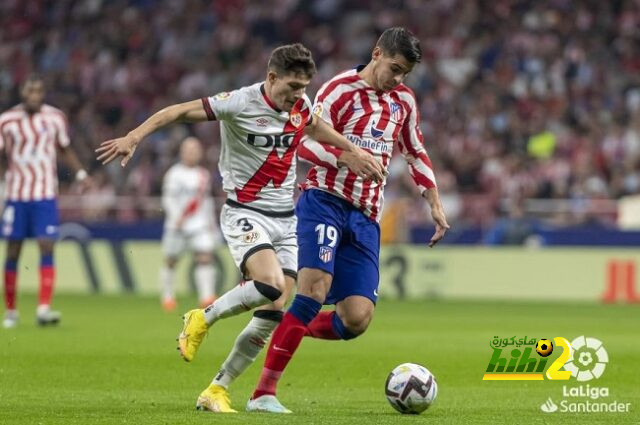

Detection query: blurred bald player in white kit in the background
xmin=160 ymin=137 xmax=217 ymax=311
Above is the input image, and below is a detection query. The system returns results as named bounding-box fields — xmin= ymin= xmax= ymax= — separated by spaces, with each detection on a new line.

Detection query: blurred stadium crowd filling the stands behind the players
xmin=0 ymin=0 xmax=640 ymax=235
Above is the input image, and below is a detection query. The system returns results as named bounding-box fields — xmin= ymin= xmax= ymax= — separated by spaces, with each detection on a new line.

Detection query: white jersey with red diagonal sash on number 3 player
xmin=202 ymin=83 xmax=313 ymax=213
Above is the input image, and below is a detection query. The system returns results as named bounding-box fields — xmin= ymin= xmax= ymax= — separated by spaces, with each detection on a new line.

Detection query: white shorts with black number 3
xmin=220 ymin=204 xmax=298 ymax=278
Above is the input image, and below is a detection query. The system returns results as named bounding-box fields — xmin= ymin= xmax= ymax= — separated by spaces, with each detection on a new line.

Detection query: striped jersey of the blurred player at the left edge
xmin=0 ymin=105 xmax=69 ymax=201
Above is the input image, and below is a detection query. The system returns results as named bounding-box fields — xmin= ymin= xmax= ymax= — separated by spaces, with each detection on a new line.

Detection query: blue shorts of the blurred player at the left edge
xmin=2 ymin=199 xmax=59 ymax=240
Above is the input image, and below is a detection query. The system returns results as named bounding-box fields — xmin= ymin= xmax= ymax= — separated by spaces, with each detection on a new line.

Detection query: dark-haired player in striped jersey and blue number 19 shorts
xmin=247 ymin=28 xmax=449 ymax=413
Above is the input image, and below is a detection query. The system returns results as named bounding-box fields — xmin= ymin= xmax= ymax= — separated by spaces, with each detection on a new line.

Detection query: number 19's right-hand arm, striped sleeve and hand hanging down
xmin=399 ymin=93 xmax=449 ymax=247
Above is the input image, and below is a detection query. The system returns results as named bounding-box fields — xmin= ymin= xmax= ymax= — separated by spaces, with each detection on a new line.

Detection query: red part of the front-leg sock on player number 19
xmin=252 ymin=313 xmax=307 ymax=399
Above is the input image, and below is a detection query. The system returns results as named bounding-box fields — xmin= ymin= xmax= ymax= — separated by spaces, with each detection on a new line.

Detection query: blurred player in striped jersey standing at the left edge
xmin=0 ymin=75 xmax=89 ymax=328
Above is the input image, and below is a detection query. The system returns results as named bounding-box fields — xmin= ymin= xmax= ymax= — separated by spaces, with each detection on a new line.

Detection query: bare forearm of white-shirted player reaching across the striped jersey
xmin=305 ymin=116 xmax=384 ymax=182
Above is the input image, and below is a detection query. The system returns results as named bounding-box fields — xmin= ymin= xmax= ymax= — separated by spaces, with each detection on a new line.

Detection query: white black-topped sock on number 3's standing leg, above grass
xmin=211 ymin=310 xmax=282 ymax=388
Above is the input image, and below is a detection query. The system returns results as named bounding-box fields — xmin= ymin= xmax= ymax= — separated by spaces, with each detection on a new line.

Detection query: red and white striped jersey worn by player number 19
xmin=298 ymin=69 xmax=436 ymax=220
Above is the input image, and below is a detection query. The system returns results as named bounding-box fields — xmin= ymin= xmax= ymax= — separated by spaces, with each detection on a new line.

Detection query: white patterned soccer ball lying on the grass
xmin=385 ymin=363 xmax=438 ymax=414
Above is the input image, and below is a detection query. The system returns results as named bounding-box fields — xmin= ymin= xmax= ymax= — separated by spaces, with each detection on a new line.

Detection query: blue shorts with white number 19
xmin=296 ymin=189 xmax=380 ymax=304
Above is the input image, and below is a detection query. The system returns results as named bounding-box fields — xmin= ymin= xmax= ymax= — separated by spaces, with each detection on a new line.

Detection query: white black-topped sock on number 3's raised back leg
xmin=204 ymin=280 xmax=282 ymax=326
